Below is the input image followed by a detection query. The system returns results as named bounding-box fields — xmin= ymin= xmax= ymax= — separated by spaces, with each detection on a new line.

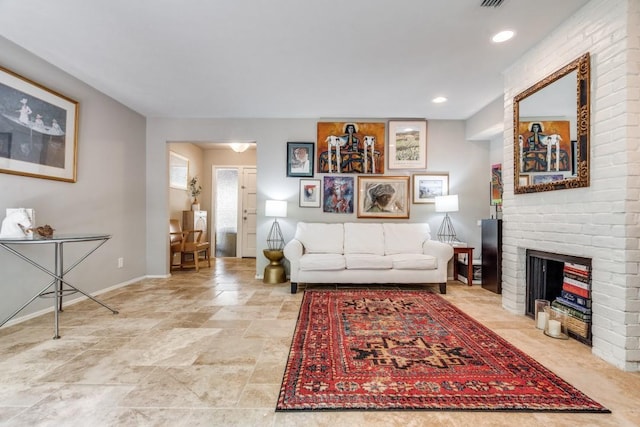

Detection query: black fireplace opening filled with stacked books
xmin=525 ymin=249 xmax=591 ymax=345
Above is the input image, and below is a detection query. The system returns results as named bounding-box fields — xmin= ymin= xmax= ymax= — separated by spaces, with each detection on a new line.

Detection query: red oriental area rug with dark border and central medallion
xmin=276 ymin=290 xmax=609 ymax=413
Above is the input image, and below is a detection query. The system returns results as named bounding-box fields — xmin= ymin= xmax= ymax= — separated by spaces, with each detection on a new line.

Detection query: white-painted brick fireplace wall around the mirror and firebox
xmin=502 ymin=0 xmax=640 ymax=371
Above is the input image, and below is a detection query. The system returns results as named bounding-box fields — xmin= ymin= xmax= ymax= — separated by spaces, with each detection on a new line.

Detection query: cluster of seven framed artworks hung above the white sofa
xmin=286 ymin=119 xmax=458 ymax=219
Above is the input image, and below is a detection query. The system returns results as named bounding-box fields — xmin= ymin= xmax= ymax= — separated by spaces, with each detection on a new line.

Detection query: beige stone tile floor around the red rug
xmin=0 ymin=258 xmax=640 ymax=427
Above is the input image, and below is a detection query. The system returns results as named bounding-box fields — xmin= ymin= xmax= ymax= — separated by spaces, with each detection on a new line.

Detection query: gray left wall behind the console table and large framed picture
xmin=0 ymin=37 xmax=146 ymax=319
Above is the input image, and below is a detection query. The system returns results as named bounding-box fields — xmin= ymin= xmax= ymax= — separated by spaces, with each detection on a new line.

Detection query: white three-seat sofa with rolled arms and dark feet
xmin=284 ymin=222 xmax=453 ymax=294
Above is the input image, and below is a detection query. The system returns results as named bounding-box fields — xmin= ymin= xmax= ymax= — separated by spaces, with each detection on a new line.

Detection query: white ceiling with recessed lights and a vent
xmin=0 ymin=0 xmax=588 ymax=119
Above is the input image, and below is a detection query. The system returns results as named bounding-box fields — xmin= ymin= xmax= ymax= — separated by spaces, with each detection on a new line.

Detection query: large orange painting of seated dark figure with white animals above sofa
xmin=317 ymin=122 xmax=385 ymax=175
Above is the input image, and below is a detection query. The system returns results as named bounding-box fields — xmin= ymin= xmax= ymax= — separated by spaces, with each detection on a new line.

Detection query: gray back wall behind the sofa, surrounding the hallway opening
xmin=147 ymin=118 xmax=490 ymax=277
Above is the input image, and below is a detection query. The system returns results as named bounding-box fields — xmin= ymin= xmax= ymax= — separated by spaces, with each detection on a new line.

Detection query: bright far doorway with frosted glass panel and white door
xmin=211 ymin=166 xmax=256 ymax=258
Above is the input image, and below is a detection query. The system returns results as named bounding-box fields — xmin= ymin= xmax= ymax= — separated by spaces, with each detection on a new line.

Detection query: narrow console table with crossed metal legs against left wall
xmin=0 ymin=234 xmax=118 ymax=339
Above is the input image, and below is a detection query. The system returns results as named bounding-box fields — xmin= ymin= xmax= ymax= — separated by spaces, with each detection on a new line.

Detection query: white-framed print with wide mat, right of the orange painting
xmin=389 ymin=120 xmax=427 ymax=169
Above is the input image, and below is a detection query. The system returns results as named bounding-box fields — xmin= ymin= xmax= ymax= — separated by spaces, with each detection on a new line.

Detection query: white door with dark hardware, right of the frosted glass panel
xmin=238 ymin=168 xmax=257 ymax=258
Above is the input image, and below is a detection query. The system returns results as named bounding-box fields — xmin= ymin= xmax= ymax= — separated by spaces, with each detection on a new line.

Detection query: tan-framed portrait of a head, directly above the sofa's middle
xmin=358 ymin=176 xmax=409 ymax=218
